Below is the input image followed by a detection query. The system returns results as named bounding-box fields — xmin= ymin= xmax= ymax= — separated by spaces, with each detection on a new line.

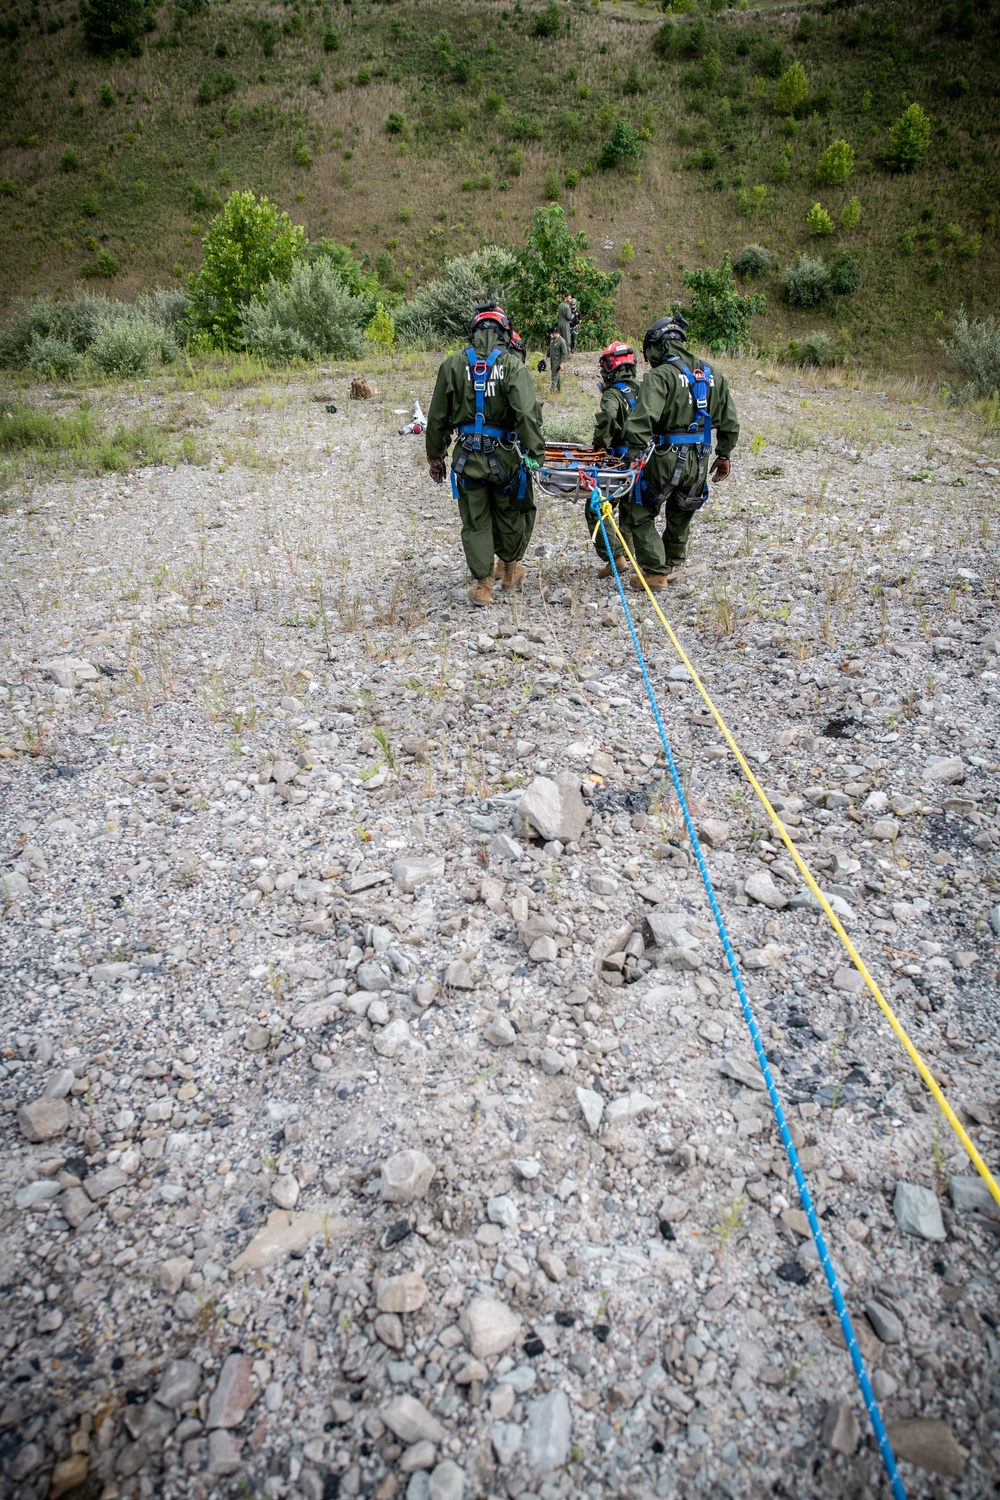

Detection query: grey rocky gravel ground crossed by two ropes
xmin=0 ymin=359 xmax=1000 ymax=1500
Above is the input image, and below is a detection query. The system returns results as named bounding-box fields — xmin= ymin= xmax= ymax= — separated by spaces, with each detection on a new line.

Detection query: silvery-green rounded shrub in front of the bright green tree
xmin=240 ymin=260 xmax=369 ymax=362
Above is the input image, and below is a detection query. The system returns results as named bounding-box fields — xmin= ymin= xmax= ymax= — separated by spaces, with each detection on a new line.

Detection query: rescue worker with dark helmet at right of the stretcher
xmin=622 ymin=312 xmax=739 ymax=593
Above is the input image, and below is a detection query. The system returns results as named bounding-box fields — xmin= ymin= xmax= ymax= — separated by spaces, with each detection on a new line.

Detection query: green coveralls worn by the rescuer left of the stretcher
xmin=426 ymin=326 xmax=546 ymax=579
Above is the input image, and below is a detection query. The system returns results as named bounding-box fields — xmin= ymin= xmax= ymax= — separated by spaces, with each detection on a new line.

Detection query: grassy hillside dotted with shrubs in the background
xmin=0 ymin=0 xmax=1000 ymax=368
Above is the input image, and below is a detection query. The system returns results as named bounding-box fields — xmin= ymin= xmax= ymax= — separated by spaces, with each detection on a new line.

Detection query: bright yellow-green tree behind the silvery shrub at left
xmin=190 ymin=191 xmax=306 ymax=348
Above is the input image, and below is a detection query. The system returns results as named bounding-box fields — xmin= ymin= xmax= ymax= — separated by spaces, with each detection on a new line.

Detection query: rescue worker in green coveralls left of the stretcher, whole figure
xmin=426 ymin=303 xmax=546 ymax=608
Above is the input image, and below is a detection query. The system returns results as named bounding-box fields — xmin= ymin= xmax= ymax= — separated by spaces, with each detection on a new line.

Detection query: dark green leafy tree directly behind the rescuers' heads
xmin=507 ymin=203 xmax=622 ymax=348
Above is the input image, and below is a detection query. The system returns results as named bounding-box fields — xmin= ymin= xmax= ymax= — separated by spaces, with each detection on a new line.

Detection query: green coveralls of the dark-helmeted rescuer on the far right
xmin=619 ymin=344 xmax=739 ymax=573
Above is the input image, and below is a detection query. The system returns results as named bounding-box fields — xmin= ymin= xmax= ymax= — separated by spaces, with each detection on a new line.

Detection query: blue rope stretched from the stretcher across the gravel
xmin=600 ymin=513 xmax=906 ymax=1500
